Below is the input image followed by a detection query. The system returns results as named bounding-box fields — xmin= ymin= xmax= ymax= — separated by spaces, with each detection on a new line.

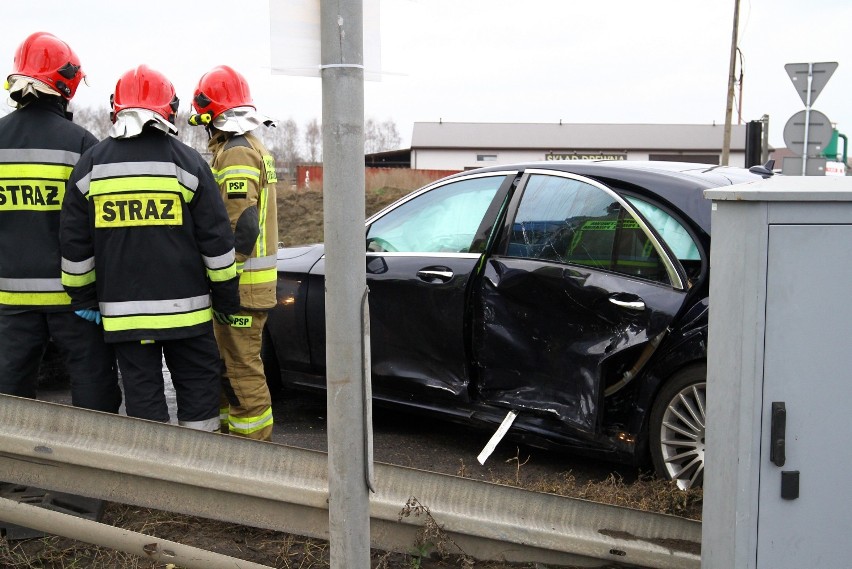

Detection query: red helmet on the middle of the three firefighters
xmin=109 ymin=65 xmax=178 ymax=123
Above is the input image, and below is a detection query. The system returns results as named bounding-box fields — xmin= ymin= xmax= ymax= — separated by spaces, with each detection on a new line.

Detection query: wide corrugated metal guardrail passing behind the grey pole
xmin=0 ymin=396 xmax=701 ymax=569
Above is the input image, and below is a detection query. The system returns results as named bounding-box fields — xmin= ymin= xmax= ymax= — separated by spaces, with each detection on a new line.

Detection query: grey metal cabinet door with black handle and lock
xmin=757 ymin=225 xmax=852 ymax=569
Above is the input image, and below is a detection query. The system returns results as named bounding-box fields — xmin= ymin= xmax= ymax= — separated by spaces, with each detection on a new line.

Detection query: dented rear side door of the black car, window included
xmin=473 ymin=170 xmax=686 ymax=435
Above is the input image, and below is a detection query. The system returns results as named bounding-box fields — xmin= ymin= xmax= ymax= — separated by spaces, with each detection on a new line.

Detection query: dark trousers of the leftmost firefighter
xmin=0 ymin=311 xmax=121 ymax=413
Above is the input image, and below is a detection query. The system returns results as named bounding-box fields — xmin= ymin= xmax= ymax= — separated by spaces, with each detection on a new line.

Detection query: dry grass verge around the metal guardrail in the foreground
xmin=0 ymin=462 xmax=702 ymax=569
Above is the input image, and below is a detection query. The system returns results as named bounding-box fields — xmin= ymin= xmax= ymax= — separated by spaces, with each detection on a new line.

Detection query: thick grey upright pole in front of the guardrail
xmin=320 ymin=0 xmax=370 ymax=569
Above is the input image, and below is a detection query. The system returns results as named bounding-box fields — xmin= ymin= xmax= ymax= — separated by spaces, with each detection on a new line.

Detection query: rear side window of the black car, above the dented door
xmin=507 ymin=174 xmax=669 ymax=283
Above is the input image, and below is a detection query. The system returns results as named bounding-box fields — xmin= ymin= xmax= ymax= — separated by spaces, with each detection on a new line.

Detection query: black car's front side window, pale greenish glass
xmin=367 ymin=175 xmax=505 ymax=253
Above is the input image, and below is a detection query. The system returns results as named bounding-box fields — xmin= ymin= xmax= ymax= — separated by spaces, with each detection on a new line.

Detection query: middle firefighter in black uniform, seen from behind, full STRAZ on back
xmin=60 ymin=65 xmax=239 ymax=431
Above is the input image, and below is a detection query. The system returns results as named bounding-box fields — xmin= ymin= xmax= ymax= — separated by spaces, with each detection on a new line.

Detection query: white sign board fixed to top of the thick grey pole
xmin=269 ymin=0 xmax=382 ymax=81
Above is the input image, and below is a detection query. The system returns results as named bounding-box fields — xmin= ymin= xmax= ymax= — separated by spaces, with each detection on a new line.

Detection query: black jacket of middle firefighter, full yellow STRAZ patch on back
xmin=60 ymin=127 xmax=239 ymax=342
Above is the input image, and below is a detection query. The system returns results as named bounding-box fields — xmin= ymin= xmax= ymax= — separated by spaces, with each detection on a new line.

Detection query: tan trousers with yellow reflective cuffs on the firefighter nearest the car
xmin=213 ymin=310 xmax=272 ymax=441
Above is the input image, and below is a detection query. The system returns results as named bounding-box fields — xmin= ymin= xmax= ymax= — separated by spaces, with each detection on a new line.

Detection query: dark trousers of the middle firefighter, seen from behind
xmin=114 ymin=330 xmax=221 ymax=431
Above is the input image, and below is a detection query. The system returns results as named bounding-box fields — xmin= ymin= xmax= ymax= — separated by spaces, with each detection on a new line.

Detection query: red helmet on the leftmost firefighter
xmin=9 ymin=32 xmax=85 ymax=99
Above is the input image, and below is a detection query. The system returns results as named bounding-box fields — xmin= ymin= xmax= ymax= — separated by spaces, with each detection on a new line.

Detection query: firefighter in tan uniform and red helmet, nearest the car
xmin=189 ymin=66 xmax=278 ymax=440
